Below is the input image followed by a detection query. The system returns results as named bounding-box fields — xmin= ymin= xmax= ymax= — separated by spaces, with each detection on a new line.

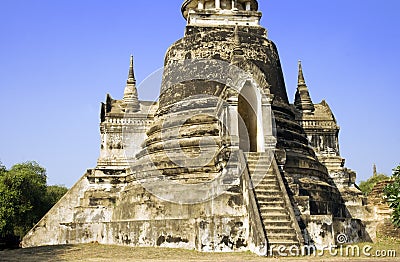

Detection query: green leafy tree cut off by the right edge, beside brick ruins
xmin=383 ymin=165 xmax=400 ymax=227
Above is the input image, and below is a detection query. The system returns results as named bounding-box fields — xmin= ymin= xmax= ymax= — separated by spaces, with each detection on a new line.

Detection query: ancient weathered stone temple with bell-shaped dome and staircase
xmin=23 ymin=0 xmax=373 ymax=254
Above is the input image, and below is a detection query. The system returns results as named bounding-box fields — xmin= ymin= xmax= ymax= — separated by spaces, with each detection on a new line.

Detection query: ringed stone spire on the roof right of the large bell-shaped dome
xmin=294 ymin=61 xmax=315 ymax=113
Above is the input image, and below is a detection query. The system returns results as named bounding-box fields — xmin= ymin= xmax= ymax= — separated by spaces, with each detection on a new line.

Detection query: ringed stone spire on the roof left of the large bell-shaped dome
xmin=123 ymin=55 xmax=140 ymax=113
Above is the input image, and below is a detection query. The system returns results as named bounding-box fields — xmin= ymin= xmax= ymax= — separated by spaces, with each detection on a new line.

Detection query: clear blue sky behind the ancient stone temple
xmin=0 ymin=0 xmax=400 ymax=186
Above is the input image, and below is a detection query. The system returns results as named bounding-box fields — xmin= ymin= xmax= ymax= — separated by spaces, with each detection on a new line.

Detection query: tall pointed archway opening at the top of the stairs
xmin=238 ymin=82 xmax=258 ymax=152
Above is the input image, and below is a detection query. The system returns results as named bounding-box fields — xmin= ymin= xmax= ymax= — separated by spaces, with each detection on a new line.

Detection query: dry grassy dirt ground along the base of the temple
xmin=0 ymin=239 xmax=400 ymax=262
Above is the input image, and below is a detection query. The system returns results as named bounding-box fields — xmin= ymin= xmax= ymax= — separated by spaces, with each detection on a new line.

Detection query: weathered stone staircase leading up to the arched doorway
xmin=245 ymin=153 xmax=302 ymax=250
